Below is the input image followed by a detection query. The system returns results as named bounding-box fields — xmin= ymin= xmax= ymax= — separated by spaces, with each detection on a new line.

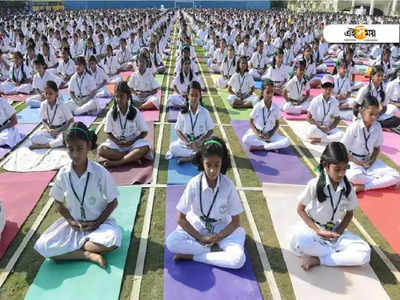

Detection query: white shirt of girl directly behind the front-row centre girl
xmin=175 ymin=105 xmax=214 ymax=137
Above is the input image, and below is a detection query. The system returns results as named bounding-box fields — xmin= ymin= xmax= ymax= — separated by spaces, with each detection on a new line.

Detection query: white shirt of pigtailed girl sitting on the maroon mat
xmin=104 ymin=103 xmax=148 ymax=141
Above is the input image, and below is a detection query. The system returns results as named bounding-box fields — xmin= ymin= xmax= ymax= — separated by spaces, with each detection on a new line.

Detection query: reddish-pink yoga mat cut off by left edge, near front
xmin=0 ymin=171 xmax=56 ymax=258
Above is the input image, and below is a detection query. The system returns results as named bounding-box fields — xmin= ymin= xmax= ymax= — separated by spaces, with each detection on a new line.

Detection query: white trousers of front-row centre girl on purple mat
xmin=165 ymin=227 xmax=246 ymax=269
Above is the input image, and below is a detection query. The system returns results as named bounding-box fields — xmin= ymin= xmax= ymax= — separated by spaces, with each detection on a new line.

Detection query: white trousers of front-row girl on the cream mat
xmin=290 ymin=223 xmax=371 ymax=267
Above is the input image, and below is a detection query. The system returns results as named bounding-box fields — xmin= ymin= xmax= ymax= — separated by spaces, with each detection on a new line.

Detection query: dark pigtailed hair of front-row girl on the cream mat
xmin=317 ymin=142 xmax=352 ymax=202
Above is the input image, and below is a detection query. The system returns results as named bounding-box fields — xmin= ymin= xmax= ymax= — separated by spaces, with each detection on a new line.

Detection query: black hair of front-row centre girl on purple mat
xmin=192 ymin=136 xmax=231 ymax=175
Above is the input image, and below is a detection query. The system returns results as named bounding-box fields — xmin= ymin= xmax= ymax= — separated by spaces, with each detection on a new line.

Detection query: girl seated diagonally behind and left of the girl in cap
xmin=281 ymin=60 xmax=310 ymax=115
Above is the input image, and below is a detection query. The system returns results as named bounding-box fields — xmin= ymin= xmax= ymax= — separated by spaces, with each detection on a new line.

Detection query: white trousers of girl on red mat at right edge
xmin=346 ymin=160 xmax=400 ymax=190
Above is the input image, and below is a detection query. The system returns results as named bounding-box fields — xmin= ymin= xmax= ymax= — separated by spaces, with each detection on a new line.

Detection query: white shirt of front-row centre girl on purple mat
xmin=176 ymin=172 xmax=243 ymax=231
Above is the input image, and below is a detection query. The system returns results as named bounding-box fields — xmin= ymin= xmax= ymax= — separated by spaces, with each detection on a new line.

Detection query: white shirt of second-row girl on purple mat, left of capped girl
xmin=250 ymin=100 xmax=281 ymax=133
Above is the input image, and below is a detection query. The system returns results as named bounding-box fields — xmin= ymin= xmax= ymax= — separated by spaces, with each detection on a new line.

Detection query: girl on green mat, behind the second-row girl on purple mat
xmin=227 ymin=56 xmax=259 ymax=108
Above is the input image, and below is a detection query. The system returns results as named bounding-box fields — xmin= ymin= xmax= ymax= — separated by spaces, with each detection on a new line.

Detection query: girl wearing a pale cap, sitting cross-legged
xmin=306 ymin=75 xmax=344 ymax=144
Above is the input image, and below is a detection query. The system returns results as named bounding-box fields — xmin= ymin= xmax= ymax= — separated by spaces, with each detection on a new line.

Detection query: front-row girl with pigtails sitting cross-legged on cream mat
xmin=290 ymin=142 xmax=371 ymax=271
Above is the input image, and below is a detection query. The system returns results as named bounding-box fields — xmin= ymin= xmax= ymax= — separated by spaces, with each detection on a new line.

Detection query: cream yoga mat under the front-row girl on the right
xmin=263 ymin=183 xmax=390 ymax=300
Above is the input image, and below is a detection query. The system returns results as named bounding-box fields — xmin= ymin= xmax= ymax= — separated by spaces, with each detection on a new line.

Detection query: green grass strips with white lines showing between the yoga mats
xmin=0 ymin=25 xmax=400 ymax=300
